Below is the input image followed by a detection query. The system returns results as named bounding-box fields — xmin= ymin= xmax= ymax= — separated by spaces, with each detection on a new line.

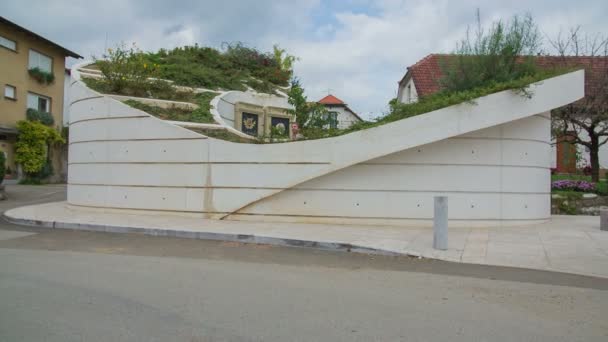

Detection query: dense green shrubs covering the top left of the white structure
xmin=91 ymin=42 xmax=297 ymax=96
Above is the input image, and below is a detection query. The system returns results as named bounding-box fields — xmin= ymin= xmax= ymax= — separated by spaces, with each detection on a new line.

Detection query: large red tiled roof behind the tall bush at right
xmin=406 ymin=54 xmax=608 ymax=96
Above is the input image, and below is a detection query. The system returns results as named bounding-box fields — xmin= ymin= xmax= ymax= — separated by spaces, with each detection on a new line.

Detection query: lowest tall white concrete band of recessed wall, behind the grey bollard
xmin=239 ymin=189 xmax=550 ymax=222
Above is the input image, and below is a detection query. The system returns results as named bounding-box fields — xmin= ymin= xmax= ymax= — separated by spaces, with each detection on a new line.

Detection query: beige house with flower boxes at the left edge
xmin=0 ymin=17 xmax=82 ymax=177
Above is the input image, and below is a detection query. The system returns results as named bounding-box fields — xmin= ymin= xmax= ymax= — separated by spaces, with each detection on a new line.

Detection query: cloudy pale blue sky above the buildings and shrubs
xmin=0 ymin=0 xmax=608 ymax=119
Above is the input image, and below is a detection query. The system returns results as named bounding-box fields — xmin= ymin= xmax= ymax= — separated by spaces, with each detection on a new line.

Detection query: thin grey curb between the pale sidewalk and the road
xmin=2 ymin=212 xmax=408 ymax=257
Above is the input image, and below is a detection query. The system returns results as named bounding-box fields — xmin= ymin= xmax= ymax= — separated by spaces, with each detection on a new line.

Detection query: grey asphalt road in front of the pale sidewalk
xmin=0 ymin=186 xmax=608 ymax=342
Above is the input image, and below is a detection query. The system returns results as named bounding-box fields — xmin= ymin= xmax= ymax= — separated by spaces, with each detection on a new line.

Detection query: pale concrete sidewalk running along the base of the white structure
xmin=4 ymin=202 xmax=608 ymax=277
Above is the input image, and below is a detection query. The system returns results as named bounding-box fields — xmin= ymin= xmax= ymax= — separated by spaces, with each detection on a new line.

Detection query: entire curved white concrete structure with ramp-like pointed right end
xmin=68 ymin=67 xmax=584 ymax=225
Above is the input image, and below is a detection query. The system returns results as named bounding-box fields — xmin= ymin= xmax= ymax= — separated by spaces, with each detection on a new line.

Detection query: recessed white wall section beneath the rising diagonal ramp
xmin=231 ymin=113 xmax=551 ymax=226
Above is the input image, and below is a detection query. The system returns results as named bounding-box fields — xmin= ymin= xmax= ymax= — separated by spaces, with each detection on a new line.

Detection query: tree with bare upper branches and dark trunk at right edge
xmin=549 ymin=26 xmax=608 ymax=182
